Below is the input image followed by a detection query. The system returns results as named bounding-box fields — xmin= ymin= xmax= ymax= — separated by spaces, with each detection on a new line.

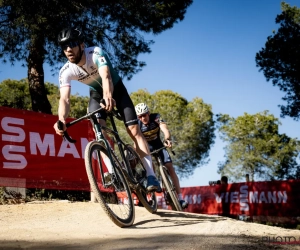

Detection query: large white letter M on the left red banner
xmin=29 ymin=132 xmax=55 ymax=156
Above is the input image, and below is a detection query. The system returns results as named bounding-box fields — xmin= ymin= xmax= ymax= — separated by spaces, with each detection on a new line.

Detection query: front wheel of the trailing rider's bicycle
xmin=159 ymin=166 xmax=182 ymax=211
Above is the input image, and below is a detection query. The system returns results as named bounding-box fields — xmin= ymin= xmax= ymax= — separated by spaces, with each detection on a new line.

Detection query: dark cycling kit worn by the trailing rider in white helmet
xmin=139 ymin=113 xmax=172 ymax=164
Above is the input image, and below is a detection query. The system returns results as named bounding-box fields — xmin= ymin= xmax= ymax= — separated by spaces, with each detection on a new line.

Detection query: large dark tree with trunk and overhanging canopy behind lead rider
xmin=0 ymin=0 xmax=192 ymax=114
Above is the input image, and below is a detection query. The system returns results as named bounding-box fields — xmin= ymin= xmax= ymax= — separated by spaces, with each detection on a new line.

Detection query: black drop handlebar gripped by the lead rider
xmin=56 ymin=99 xmax=123 ymax=143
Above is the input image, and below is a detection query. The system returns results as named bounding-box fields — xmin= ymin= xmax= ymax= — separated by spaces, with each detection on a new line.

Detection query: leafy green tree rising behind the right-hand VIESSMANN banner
xmin=218 ymin=111 xmax=300 ymax=181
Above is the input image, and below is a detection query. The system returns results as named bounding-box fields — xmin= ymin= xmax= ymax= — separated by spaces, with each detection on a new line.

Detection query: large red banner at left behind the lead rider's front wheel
xmin=0 ymin=107 xmax=94 ymax=190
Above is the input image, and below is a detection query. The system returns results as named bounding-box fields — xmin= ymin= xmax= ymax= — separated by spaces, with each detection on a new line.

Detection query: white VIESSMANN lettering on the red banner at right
xmin=214 ymin=185 xmax=288 ymax=211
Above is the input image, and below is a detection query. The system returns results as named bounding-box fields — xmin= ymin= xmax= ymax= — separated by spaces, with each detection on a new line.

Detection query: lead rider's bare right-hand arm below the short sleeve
xmin=98 ymin=65 xmax=115 ymax=110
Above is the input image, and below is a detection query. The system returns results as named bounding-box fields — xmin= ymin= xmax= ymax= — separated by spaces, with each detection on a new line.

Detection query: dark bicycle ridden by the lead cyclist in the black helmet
xmin=57 ymin=102 xmax=157 ymax=227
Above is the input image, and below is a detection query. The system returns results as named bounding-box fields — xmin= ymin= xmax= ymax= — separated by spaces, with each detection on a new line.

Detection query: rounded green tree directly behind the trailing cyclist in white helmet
xmin=129 ymin=90 xmax=215 ymax=177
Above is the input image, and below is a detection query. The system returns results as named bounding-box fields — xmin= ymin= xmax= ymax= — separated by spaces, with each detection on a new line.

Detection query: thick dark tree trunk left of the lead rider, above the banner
xmin=27 ymin=36 xmax=52 ymax=114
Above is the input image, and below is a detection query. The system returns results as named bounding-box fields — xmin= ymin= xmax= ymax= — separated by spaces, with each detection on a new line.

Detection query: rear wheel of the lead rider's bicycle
xmin=124 ymin=144 xmax=157 ymax=213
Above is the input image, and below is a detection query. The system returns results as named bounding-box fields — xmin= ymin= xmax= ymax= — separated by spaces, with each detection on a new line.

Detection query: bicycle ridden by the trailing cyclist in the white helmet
xmin=151 ymin=146 xmax=182 ymax=211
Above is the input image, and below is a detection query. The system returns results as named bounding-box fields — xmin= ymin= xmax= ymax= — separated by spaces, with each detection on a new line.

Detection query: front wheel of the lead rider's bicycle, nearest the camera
xmin=85 ymin=141 xmax=135 ymax=227
